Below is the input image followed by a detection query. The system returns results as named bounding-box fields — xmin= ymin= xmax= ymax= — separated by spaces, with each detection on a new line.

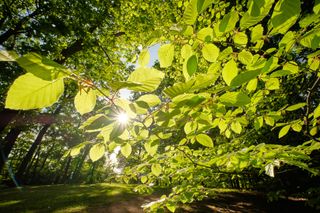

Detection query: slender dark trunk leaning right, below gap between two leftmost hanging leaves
xmin=16 ymin=105 xmax=61 ymax=181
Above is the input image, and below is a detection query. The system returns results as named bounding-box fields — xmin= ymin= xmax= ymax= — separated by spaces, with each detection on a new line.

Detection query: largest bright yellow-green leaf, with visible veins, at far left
xmin=5 ymin=73 xmax=64 ymax=110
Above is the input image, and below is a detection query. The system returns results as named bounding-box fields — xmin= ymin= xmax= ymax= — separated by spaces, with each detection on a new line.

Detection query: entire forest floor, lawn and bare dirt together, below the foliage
xmin=0 ymin=183 xmax=317 ymax=213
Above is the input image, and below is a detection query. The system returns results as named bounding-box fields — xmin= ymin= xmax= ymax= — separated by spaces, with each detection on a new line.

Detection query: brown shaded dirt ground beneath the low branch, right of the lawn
xmin=86 ymin=192 xmax=319 ymax=213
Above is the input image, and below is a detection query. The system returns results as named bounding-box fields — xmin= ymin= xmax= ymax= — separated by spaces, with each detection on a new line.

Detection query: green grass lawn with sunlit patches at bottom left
xmin=0 ymin=184 xmax=141 ymax=212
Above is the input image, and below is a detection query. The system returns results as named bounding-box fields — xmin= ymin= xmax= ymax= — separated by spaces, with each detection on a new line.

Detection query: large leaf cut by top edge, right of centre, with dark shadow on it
xmin=240 ymin=0 xmax=274 ymax=30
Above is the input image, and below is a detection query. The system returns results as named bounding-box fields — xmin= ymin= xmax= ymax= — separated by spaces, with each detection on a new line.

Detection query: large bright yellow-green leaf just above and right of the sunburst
xmin=128 ymin=67 xmax=164 ymax=92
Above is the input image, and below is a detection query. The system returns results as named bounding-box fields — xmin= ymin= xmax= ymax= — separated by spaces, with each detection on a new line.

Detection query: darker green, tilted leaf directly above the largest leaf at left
xmin=16 ymin=53 xmax=70 ymax=81
